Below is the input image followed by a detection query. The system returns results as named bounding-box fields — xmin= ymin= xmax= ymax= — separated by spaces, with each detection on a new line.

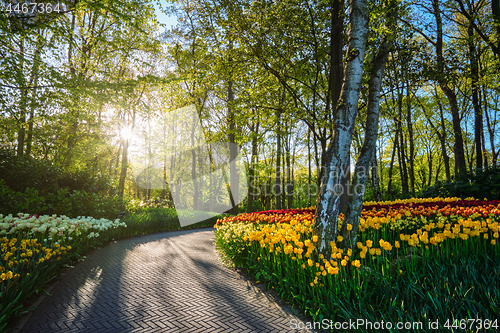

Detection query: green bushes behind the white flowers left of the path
xmin=0 ymin=150 xmax=124 ymax=218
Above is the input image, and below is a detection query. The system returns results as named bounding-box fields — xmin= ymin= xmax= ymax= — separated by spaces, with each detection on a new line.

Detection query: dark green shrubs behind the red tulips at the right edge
xmin=420 ymin=168 xmax=500 ymax=200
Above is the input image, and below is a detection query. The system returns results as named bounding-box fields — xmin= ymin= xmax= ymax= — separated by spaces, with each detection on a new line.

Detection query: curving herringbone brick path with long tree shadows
xmin=17 ymin=229 xmax=314 ymax=333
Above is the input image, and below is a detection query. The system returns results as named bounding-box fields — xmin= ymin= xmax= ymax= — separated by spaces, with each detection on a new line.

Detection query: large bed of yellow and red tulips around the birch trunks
xmin=215 ymin=198 xmax=500 ymax=332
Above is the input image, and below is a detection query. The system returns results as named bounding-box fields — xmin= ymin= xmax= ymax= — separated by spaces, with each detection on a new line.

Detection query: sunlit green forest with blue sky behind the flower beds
xmin=0 ymin=0 xmax=500 ymax=217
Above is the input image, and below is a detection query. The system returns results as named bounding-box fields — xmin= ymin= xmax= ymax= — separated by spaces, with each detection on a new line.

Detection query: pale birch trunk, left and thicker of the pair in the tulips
xmin=314 ymin=0 xmax=369 ymax=254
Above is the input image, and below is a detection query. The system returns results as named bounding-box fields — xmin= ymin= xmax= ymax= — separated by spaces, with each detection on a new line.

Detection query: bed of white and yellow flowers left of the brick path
xmin=0 ymin=214 xmax=126 ymax=331
